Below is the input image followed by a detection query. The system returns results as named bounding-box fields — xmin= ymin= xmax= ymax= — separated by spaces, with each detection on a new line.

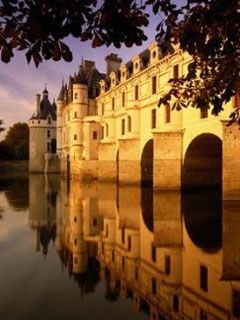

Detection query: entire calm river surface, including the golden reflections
xmin=0 ymin=175 xmax=240 ymax=320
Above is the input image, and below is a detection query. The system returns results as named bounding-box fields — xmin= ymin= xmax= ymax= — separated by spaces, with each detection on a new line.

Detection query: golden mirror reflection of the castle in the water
xmin=29 ymin=175 xmax=240 ymax=320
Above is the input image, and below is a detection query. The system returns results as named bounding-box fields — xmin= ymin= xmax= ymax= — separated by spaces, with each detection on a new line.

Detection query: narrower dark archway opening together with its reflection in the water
xmin=141 ymin=139 xmax=153 ymax=232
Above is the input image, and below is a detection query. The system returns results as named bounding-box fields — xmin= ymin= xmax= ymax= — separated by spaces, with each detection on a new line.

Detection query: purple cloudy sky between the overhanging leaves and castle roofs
xmin=0 ymin=0 xmax=186 ymax=140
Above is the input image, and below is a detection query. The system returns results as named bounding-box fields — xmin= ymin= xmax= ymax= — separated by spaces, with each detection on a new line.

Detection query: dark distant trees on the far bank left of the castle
xmin=0 ymin=122 xmax=29 ymax=160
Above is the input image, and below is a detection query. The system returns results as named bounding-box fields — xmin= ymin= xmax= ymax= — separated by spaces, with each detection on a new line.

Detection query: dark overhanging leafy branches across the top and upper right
xmin=0 ymin=0 xmax=240 ymax=117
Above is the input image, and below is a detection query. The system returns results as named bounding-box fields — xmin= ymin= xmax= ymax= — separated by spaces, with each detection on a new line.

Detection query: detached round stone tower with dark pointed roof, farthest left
xmin=28 ymin=87 xmax=56 ymax=173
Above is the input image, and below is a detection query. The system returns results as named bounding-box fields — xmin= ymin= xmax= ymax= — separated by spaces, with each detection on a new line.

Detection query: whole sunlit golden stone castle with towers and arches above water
xmin=29 ymin=43 xmax=240 ymax=200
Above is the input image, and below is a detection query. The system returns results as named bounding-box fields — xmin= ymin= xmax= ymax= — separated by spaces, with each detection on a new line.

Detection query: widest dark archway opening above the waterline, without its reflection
xmin=182 ymin=133 xmax=222 ymax=189
